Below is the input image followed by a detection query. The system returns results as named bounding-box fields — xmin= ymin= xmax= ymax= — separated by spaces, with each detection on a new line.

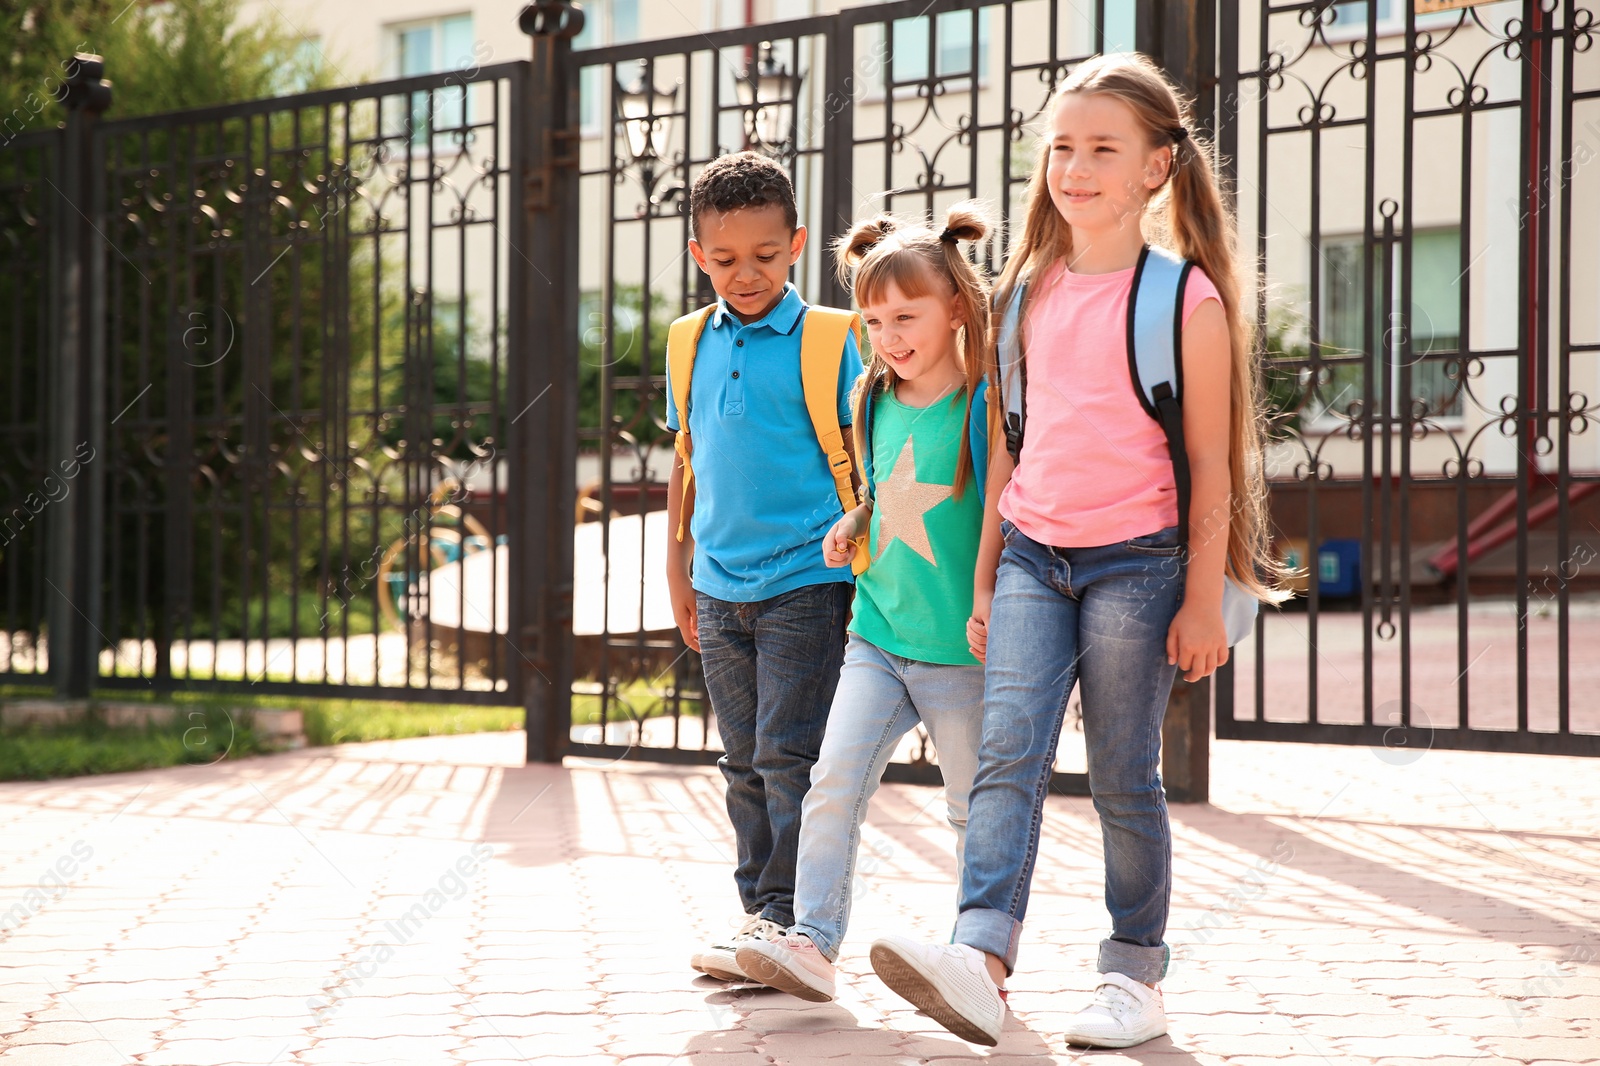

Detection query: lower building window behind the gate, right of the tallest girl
xmin=1310 ymin=227 xmax=1462 ymax=421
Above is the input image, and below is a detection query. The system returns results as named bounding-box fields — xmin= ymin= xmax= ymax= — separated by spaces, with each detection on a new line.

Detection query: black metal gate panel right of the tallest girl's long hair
xmin=1216 ymin=2 xmax=1600 ymax=760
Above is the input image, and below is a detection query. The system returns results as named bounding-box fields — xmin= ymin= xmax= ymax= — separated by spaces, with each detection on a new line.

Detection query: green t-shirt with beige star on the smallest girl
xmin=850 ymin=382 xmax=984 ymax=666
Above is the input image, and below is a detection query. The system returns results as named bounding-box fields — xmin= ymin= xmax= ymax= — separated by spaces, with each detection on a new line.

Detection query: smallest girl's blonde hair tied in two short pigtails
xmin=834 ymin=200 xmax=992 ymax=498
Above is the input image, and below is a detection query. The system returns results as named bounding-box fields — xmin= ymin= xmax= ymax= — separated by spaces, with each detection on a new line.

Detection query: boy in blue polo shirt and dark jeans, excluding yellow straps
xmin=667 ymin=152 xmax=861 ymax=981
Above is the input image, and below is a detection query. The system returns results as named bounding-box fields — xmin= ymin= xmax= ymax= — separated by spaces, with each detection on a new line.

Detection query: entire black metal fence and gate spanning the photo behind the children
xmin=0 ymin=0 xmax=1600 ymax=781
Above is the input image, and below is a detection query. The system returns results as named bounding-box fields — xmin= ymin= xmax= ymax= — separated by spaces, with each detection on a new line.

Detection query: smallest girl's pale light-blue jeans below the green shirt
xmin=794 ymin=634 xmax=984 ymax=959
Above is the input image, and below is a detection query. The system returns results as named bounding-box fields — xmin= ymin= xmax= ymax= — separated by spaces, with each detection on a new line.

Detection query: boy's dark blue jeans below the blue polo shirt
xmin=694 ymin=581 xmax=854 ymax=927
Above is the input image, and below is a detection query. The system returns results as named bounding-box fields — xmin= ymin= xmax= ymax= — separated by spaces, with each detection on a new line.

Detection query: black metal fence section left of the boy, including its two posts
xmin=0 ymin=29 xmax=573 ymax=757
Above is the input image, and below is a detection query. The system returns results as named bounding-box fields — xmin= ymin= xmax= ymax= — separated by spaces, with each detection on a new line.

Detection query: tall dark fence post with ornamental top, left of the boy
xmin=507 ymin=0 xmax=584 ymax=762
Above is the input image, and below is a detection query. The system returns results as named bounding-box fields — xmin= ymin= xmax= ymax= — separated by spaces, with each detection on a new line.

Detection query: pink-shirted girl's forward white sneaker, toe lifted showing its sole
xmin=872 ymin=936 xmax=1005 ymax=1047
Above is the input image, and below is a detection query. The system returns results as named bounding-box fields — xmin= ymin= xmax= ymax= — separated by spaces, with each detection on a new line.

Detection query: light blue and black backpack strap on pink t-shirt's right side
xmin=1128 ymin=245 xmax=1194 ymax=546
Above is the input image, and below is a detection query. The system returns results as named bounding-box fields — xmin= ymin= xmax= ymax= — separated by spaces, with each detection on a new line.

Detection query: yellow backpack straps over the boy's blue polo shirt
xmin=667 ymin=304 xmax=869 ymax=575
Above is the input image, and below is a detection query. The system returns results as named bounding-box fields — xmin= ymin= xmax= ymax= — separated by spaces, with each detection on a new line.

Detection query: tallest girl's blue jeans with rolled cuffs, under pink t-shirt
xmin=954 ymin=522 xmax=1184 ymax=984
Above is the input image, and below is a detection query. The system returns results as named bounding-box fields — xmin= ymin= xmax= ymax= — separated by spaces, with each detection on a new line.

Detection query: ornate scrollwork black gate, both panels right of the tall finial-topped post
xmin=573 ymin=0 xmax=1600 ymax=771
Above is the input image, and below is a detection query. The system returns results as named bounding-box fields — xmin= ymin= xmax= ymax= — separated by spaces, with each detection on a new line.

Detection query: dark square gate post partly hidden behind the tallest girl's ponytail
xmin=1134 ymin=0 xmax=1226 ymax=804
